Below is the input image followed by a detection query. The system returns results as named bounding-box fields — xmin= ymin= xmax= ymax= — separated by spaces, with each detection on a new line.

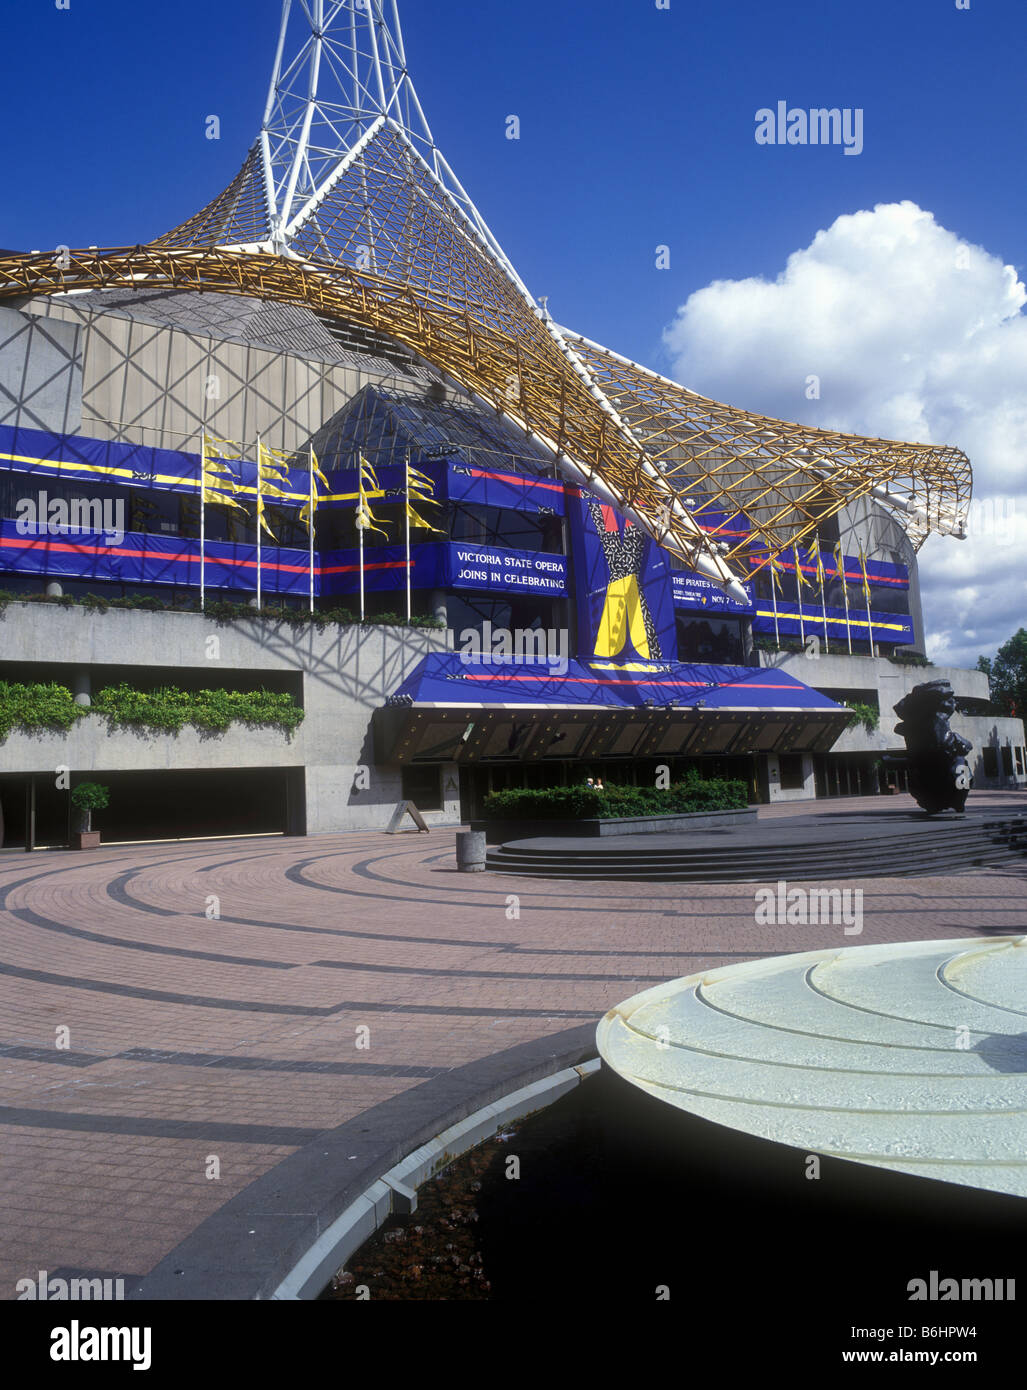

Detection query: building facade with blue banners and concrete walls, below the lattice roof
xmin=0 ymin=284 xmax=1027 ymax=845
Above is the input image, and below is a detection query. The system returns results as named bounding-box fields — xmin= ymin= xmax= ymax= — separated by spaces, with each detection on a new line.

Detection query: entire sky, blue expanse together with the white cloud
xmin=0 ymin=0 xmax=1027 ymax=657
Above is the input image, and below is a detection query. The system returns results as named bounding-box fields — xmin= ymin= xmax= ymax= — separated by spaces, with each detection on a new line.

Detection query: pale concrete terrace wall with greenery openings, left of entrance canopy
xmin=0 ymin=603 xmax=460 ymax=834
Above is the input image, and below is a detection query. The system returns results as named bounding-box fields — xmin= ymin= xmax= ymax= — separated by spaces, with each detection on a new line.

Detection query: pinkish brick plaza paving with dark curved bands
xmin=0 ymin=803 xmax=1027 ymax=1298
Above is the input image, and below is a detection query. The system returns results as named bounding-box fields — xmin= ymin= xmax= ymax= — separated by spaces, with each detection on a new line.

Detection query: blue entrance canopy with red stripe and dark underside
xmin=375 ymin=652 xmax=852 ymax=763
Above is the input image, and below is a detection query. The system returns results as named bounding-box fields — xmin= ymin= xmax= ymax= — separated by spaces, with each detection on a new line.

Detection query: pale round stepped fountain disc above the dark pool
xmin=598 ymin=937 xmax=1027 ymax=1197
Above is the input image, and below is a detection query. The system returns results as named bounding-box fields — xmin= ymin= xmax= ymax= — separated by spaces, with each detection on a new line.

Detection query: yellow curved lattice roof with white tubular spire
xmin=0 ymin=0 xmax=971 ymax=596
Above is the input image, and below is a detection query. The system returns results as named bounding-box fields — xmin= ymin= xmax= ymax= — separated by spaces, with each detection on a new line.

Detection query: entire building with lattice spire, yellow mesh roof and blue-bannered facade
xmin=0 ymin=0 xmax=1026 ymax=847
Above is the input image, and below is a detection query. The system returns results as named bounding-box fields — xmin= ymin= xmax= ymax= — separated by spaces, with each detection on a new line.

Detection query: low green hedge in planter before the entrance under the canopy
xmin=485 ymin=773 xmax=749 ymax=820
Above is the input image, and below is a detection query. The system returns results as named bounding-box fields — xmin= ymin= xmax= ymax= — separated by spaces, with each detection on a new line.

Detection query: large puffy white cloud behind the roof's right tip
xmin=664 ymin=202 xmax=1027 ymax=666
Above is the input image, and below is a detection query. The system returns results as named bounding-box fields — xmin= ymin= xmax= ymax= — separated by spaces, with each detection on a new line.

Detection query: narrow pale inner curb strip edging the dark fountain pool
xmin=271 ymin=1056 xmax=602 ymax=1300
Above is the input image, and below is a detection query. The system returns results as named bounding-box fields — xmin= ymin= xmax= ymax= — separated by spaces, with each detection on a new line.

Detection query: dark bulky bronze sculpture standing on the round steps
xmin=884 ymin=681 xmax=973 ymax=816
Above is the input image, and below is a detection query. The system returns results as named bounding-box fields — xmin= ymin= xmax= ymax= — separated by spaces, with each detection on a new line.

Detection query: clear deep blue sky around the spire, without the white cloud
xmin=0 ymin=0 xmax=1027 ymax=367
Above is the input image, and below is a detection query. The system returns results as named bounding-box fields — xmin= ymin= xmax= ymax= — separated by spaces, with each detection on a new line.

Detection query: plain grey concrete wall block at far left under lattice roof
xmin=0 ymin=306 xmax=82 ymax=434
